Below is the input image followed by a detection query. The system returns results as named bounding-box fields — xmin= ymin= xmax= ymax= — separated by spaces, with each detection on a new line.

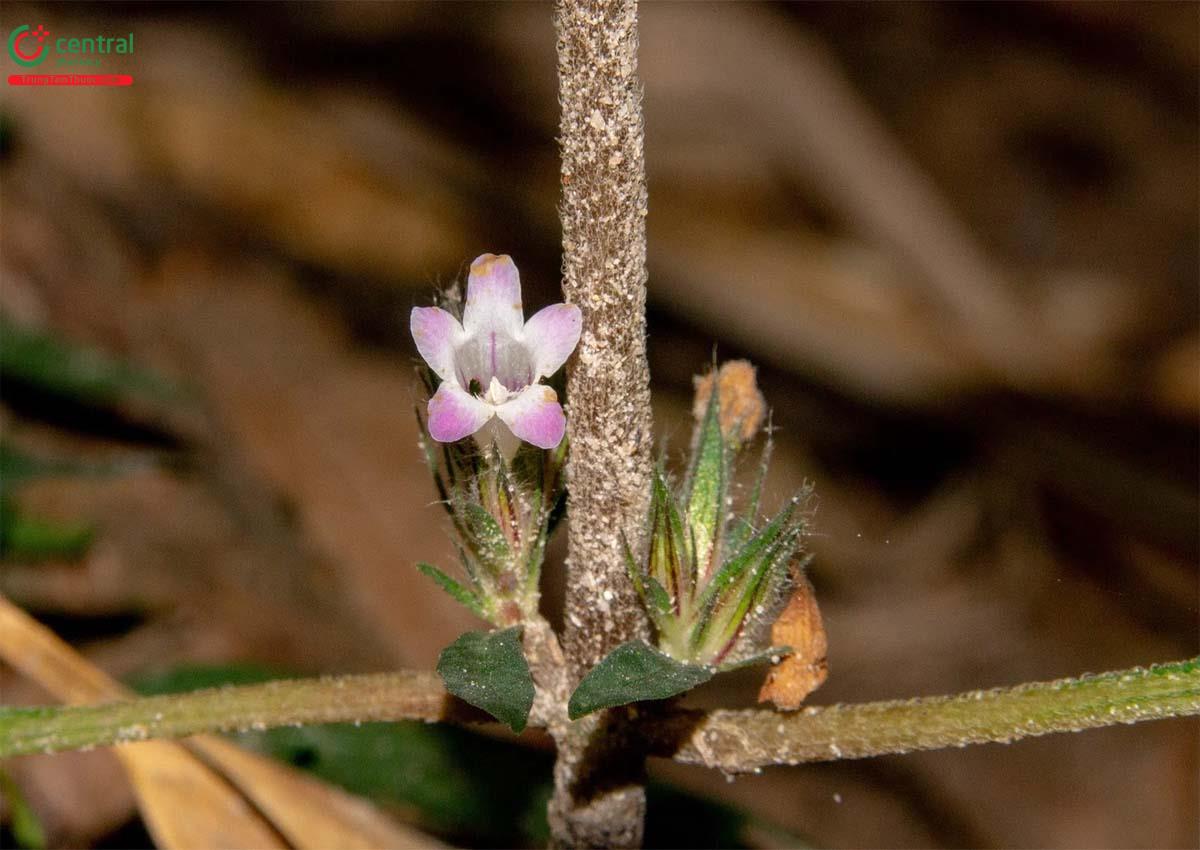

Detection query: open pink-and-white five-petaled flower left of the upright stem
xmin=410 ymin=253 xmax=582 ymax=449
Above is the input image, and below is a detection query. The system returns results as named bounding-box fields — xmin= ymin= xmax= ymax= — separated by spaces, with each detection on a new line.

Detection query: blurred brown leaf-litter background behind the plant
xmin=0 ymin=1 xmax=1200 ymax=848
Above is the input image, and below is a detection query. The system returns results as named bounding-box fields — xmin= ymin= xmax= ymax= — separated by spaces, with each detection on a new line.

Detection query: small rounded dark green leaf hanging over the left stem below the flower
xmin=438 ymin=625 xmax=534 ymax=732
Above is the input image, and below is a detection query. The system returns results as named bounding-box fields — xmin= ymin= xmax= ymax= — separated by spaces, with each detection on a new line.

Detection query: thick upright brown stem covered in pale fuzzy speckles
xmin=550 ymin=0 xmax=652 ymax=846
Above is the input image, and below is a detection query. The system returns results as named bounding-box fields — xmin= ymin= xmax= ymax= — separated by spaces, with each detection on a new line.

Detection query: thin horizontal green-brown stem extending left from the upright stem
xmin=0 ymin=672 xmax=477 ymax=759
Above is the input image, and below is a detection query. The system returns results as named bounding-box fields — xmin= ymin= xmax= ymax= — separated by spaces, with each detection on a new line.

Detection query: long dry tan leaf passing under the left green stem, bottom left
xmin=0 ymin=595 xmax=440 ymax=850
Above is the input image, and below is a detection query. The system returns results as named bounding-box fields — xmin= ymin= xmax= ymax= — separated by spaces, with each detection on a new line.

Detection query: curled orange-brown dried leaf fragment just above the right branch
xmin=758 ymin=575 xmax=829 ymax=711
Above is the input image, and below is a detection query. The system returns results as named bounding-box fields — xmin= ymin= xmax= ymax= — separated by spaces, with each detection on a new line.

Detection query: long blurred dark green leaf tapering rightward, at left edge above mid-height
xmin=0 ymin=315 xmax=181 ymax=403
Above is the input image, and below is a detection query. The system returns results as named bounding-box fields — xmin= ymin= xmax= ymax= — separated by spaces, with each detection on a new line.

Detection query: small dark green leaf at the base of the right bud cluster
xmin=566 ymin=640 xmax=713 ymax=720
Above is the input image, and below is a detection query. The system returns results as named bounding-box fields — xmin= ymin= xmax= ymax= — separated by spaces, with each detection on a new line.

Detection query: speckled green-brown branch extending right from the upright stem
xmin=648 ymin=658 xmax=1200 ymax=773
